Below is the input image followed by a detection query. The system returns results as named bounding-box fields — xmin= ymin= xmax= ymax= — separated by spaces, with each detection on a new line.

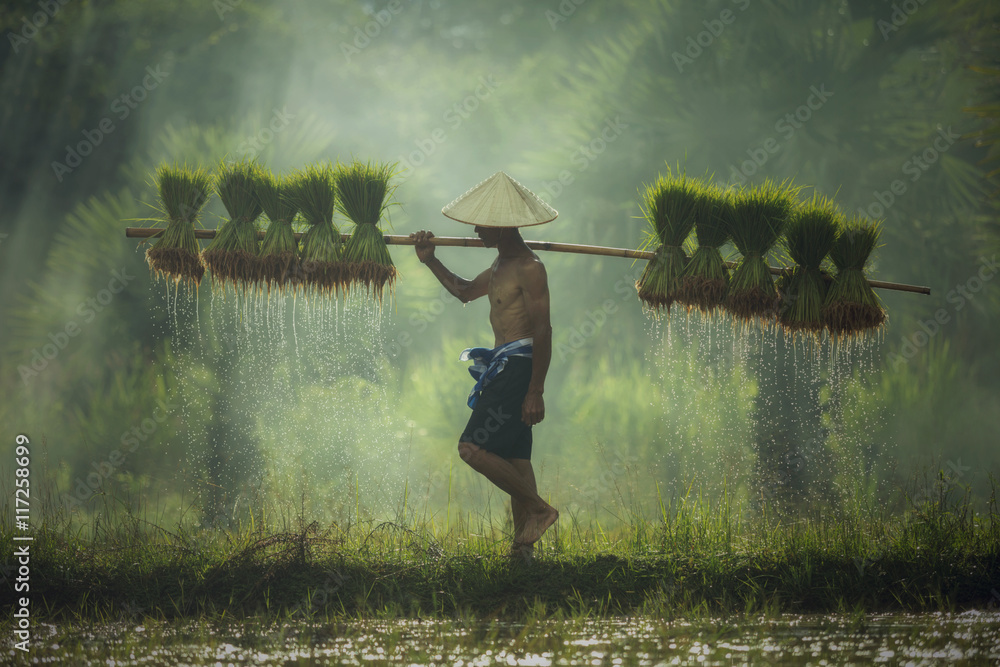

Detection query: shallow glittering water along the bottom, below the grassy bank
xmin=10 ymin=611 xmax=1000 ymax=665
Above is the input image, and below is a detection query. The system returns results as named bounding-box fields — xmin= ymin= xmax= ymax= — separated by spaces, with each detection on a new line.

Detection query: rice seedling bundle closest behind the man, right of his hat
xmin=635 ymin=170 xmax=704 ymax=313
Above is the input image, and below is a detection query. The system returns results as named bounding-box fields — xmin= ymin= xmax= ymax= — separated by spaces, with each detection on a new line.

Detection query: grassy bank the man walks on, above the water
xmin=0 ymin=478 xmax=1000 ymax=621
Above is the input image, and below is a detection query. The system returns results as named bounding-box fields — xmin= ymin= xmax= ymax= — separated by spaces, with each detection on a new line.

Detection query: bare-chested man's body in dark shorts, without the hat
xmin=410 ymin=225 xmax=559 ymax=559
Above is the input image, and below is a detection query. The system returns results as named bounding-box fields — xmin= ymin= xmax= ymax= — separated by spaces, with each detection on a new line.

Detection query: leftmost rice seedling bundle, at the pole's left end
xmin=146 ymin=164 xmax=212 ymax=286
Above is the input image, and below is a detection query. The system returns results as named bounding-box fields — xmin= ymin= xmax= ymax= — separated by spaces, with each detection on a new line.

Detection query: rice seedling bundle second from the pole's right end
xmin=778 ymin=194 xmax=843 ymax=337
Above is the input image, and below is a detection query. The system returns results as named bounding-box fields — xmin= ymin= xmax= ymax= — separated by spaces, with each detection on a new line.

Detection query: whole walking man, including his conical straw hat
xmin=410 ymin=172 xmax=559 ymax=560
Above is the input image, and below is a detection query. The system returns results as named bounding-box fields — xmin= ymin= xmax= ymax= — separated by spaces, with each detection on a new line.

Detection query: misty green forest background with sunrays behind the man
xmin=0 ymin=0 xmax=1000 ymax=523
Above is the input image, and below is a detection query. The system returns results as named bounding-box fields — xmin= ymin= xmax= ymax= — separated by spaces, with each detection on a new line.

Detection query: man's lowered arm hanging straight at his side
xmin=521 ymin=260 xmax=552 ymax=426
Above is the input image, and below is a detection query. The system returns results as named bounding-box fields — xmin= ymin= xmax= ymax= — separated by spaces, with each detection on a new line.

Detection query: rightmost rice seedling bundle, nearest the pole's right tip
xmin=823 ymin=217 xmax=885 ymax=338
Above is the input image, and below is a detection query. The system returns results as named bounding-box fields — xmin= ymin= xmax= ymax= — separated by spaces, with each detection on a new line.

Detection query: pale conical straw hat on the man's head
xmin=441 ymin=171 xmax=559 ymax=227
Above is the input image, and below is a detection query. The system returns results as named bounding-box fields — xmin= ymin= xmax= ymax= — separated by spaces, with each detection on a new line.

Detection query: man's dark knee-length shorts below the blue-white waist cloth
xmin=458 ymin=357 xmax=531 ymax=459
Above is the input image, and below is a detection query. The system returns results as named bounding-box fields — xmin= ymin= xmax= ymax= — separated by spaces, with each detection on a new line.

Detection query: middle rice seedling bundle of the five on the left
xmin=257 ymin=172 xmax=299 ymax=293
